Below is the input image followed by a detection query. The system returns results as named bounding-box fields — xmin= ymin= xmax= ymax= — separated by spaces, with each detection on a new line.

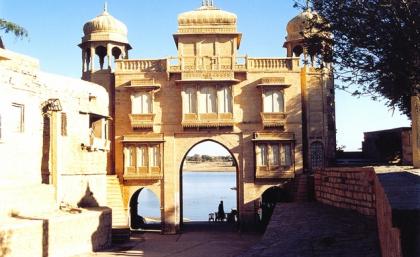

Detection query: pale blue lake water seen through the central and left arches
xmin=139 ymin=171 xmax=236 ymax=221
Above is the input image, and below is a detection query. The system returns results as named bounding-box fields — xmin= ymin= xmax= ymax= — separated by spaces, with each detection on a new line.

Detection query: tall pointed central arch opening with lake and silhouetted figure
xmin=180 ymin=140 xmax=239 ymax=227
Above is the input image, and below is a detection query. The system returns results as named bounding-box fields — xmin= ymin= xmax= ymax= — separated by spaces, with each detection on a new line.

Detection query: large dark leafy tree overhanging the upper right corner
xmin=304 ymin=0 xmax=420 ymax=116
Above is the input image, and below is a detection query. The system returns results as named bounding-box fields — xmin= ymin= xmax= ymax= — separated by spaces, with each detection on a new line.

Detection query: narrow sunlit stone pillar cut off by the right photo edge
xmin=411 ymin=95 xmax=420 ymax=168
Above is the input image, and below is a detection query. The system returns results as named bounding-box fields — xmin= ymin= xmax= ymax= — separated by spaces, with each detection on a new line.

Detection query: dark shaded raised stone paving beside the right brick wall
xmin=240 ymin=202 xmax=380 ymax=257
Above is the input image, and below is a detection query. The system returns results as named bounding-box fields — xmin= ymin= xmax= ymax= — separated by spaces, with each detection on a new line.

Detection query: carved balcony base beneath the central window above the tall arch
xmin=182 ymin=113 xmax=234 ymax=128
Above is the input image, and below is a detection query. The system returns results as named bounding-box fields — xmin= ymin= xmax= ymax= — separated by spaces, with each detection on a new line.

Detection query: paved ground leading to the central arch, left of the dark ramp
xmin=75 ymin=222 xmax=261 ymax=257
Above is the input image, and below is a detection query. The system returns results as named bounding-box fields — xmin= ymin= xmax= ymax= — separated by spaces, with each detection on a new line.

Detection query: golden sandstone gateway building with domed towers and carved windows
xmin=79 ymin=1 xmax=335 ymax=233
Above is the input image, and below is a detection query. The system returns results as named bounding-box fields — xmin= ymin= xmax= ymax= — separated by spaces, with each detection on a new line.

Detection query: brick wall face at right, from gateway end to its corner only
xmin=315 ymin=168 xmax=376 ymax=216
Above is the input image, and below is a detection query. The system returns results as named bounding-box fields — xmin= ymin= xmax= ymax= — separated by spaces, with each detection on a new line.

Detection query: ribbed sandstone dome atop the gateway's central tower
xmin=178 ymin=5 xmax=237 ymax=26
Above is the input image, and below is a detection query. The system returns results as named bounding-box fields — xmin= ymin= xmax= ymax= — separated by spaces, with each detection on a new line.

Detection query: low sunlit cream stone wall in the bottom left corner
xmin=0 ymin=207 xmax=112 ymax=257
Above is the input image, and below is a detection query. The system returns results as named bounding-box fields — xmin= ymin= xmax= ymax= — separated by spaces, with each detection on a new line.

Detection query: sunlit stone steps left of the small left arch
xmin=107 ymin=175 xmax=130 ymax=242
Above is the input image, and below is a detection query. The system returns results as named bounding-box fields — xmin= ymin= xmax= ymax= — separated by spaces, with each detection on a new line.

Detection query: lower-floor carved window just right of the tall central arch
xmin=256 ymin=142 xmax=292 ymax=169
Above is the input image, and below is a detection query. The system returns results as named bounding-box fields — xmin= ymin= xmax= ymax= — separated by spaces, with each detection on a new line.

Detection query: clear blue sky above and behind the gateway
xmin=0 ymin=0 xmax=410 ymax=151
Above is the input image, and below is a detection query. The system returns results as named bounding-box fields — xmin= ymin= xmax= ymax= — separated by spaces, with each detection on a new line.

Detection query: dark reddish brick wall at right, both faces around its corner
xmin=315 ymin=167 xmax=411 ymax=257
